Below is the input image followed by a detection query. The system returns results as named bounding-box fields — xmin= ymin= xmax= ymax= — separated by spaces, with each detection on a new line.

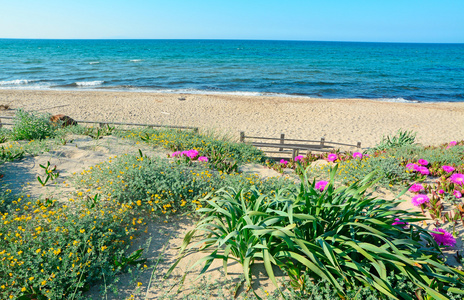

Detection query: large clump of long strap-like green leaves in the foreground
xmin=171 ymin=167 xmax=464 ymax=299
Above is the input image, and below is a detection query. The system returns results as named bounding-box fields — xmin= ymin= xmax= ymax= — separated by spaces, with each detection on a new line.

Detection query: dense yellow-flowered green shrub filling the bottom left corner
xmin=0 ymin=197 xmax=140 ymax=299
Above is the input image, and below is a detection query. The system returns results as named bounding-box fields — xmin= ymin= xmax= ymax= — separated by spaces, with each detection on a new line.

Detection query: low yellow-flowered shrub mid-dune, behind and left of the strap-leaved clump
xmin=76 ymin=155 xmax=289 ymax=214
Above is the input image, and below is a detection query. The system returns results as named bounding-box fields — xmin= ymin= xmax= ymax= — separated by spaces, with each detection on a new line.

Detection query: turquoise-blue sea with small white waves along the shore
xmin=0 ymin=39 xmax=464 ymax=102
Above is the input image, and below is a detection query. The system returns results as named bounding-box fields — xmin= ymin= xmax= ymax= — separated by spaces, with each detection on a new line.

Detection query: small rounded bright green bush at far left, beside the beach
xmin=11 ymin=109 xmax=57 ymax=140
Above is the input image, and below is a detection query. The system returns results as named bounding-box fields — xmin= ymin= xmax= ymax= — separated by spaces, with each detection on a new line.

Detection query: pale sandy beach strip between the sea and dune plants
xmin=0 ymin=90 xmax=464 ymax=147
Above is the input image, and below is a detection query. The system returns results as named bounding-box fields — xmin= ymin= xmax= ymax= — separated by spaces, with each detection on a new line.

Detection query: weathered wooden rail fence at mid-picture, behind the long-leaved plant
xmin=240 ymin=131 xmax=361 ymax=159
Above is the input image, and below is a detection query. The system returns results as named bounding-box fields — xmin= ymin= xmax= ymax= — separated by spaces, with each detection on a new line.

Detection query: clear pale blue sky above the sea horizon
xmin=0 ymin=0 xmax=464 ymax=43
